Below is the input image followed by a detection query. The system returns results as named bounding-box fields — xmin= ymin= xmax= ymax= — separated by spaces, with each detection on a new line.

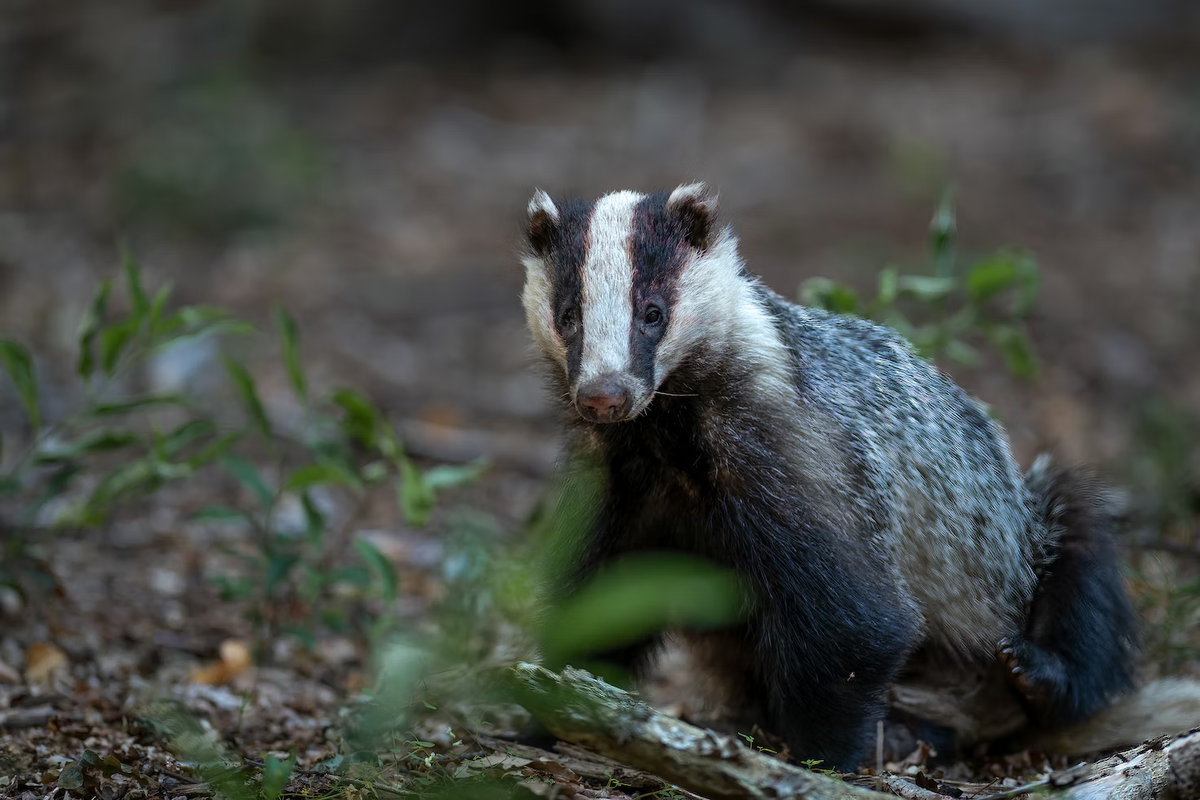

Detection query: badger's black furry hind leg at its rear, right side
xmin=1000 ymin=458 xmax=1138 ymax=726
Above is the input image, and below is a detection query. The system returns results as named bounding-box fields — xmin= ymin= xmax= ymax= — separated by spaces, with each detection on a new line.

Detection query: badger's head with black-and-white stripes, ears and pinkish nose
xmin=522 ymin=184 xmax=745 ymax=423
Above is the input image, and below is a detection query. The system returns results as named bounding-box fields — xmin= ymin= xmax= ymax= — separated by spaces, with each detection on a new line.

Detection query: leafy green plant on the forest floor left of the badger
xmin=0 ymin=254 xmax=484 ymax=652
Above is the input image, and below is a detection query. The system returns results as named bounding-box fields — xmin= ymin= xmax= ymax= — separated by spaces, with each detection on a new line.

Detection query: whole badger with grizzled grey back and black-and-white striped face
xmin=523 ymin=184 xmax=1135 ymax=768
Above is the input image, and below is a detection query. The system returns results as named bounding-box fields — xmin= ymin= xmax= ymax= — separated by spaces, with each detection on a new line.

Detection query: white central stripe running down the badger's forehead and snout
xmin=577 ymin=192 xmax=644 ymax=393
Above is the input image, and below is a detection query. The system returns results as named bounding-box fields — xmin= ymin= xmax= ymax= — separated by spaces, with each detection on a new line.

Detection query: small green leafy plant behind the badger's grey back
xmin=800 ymin=192 xmax=1038 ymax=378
